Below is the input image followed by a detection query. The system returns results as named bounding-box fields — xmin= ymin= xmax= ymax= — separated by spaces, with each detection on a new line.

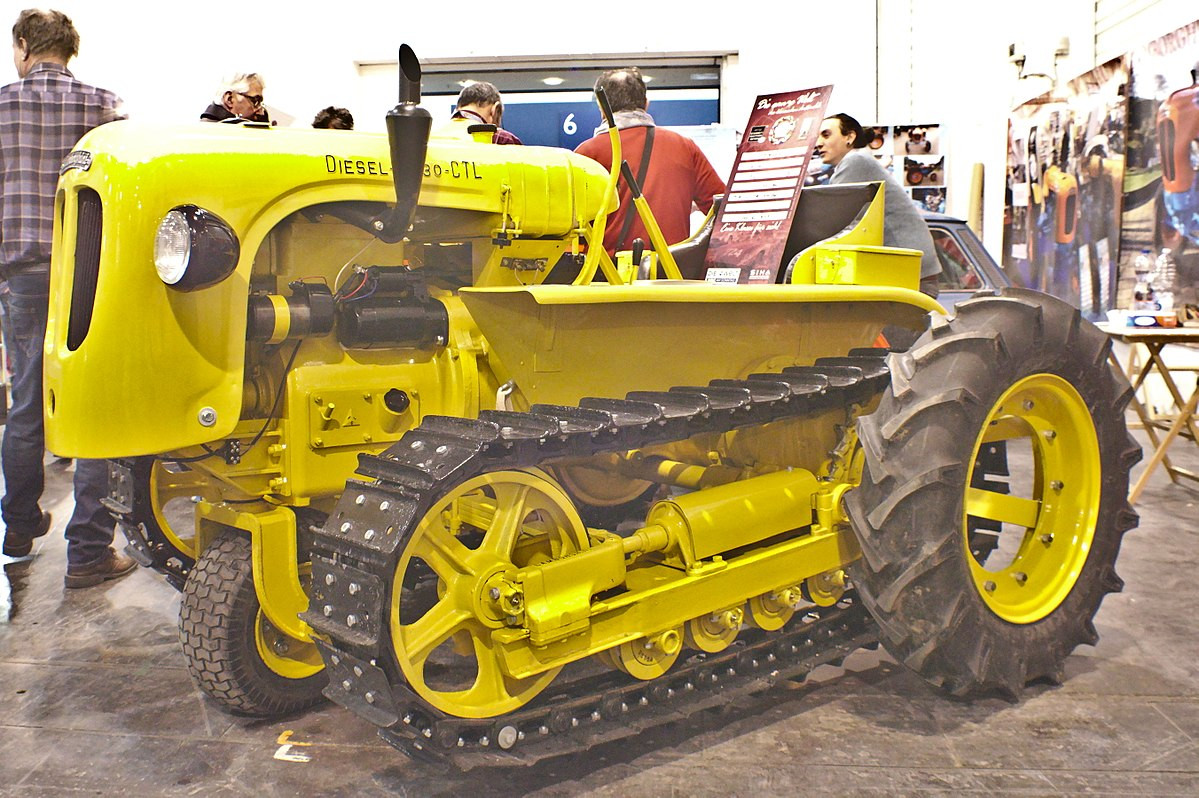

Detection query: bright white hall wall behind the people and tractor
xmin=0 ymin=0 xmax=1199 ymax=252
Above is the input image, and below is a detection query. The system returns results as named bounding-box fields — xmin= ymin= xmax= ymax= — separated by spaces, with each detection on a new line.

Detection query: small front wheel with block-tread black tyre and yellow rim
xmin=179 ymin=531 xmax=329 ymax=718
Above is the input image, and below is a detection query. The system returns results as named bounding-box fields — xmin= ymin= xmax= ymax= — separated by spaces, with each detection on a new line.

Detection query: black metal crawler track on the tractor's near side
xmin=302 ymin=349 xmax=890 ymax=764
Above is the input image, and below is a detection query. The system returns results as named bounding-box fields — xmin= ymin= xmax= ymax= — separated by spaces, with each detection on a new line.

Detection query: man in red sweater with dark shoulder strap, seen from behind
xmin=574 ymin=67 xmax=724 ymax=254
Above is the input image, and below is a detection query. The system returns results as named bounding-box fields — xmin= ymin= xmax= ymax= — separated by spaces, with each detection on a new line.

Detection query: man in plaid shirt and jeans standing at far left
xmin=0 ymin=10 xmax=137 ymax=587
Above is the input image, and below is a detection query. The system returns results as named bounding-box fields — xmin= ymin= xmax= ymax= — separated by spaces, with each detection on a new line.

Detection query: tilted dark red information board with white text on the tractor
xmin=704 ymin=86 xmax=832 ymax=284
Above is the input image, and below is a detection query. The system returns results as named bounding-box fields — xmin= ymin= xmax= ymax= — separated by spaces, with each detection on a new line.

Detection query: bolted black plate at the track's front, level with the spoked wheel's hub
xmin=301 ymin=554 xmax=385 ymax=646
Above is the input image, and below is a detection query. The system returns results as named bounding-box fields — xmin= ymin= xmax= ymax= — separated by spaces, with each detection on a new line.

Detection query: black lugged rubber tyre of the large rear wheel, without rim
xmin=845 ymin=289 xmax=1140 ymax=696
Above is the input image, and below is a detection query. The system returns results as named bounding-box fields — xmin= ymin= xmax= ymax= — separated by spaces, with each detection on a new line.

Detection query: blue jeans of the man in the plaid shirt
xmin=0 ymin=270 xmax=114 ymax=566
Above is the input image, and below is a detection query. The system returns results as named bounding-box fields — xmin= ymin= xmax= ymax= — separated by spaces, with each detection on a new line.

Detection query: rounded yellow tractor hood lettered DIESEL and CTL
xmin=44 ymin=117 xmax=608 ymax=458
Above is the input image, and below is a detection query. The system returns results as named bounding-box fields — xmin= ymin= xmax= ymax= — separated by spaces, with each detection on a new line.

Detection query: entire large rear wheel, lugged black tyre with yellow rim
xmin=846 ymin=289 xmax=1140 ymax=695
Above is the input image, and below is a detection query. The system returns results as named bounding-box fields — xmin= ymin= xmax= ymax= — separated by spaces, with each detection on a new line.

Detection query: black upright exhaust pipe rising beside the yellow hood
xmin=370 ymin=44 xmax=433 ymax=243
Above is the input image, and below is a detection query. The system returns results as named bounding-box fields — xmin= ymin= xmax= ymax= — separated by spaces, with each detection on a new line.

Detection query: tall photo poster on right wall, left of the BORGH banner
xmin=1002 ymin=56 xmax=1128 ymax=320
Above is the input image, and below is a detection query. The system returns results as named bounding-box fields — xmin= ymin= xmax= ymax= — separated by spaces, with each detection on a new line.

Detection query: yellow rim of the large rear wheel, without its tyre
xmin=962 ymin=374 xmax=1102 ymax=623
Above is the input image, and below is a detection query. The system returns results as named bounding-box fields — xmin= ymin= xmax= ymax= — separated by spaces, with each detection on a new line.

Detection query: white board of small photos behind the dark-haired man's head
xmin=803 ymin=125 xmax=948 ymax=213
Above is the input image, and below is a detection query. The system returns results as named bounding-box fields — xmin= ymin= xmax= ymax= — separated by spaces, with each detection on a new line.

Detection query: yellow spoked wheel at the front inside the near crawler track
xmin=391 ymin=471 xmax=588 ymax=718
